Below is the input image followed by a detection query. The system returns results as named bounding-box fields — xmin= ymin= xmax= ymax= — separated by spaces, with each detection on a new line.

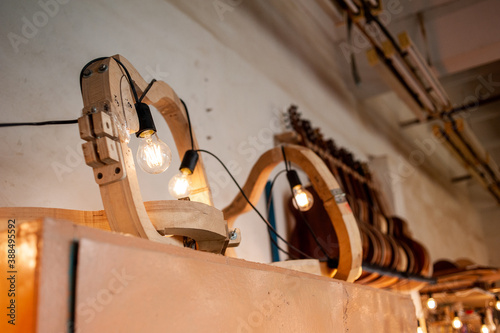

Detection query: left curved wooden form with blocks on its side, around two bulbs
xmin=78 ymin=55 xmax=239 ymax=253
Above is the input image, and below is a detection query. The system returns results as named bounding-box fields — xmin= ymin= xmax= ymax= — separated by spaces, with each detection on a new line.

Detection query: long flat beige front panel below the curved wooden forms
xmin=76 ymin=230 xmax=416 ymax=333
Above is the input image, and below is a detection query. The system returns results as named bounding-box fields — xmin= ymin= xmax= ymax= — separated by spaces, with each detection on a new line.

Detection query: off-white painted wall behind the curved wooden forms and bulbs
xmin=0 ymin=0 xmax=488 ymax=263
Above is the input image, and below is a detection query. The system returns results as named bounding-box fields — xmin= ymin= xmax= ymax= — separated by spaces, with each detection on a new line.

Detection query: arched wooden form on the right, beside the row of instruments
xmin=223 ymin=145 xmax=362 ymax=282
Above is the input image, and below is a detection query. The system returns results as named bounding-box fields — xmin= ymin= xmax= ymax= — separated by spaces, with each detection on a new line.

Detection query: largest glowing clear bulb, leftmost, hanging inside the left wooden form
xmin=137 ymin=131 xmax=172 ymax=174
